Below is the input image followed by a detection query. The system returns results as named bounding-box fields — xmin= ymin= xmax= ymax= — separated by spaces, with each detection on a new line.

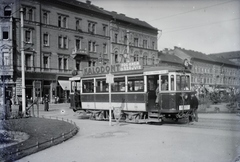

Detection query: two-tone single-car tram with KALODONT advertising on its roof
xmin=70 ymin=62 xmax=193 ymax=122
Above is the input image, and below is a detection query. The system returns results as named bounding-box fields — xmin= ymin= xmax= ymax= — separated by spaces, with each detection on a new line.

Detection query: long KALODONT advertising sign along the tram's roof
xmin=83 ymin=62 xmax=143 ymax=76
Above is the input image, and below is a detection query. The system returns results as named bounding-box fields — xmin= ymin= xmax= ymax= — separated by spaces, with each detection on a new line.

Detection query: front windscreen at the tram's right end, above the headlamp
xmin=176 ymin=75 xmax=190 ymax=91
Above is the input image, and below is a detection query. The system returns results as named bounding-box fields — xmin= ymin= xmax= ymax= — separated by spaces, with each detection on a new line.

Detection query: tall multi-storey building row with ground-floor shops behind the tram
xmin=0 ymin=0 xmax=158 ymax=102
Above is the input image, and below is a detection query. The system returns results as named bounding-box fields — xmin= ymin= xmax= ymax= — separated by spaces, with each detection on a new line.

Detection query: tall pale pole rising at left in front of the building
xmin=20 ymin=8 xmax=26 ymax=116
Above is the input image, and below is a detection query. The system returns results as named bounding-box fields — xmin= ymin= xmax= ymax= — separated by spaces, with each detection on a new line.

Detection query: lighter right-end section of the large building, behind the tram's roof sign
xmin=108 ymin=12 xmax=159 ymax=66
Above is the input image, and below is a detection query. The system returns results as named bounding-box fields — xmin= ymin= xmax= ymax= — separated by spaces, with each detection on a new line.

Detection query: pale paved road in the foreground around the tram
xmin=15 ymin=104 xmax=240 ymax=162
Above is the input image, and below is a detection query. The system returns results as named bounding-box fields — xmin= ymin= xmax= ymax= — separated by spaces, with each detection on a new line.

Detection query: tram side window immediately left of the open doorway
xmin=128 ymin=76 xmax=144 ymax=92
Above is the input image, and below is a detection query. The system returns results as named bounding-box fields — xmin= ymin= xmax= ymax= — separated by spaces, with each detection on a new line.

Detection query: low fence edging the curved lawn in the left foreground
xmin=0 ymin=116 xmax=79 ymax=162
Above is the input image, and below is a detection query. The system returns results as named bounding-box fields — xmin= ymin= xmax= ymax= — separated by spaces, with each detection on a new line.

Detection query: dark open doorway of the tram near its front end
xmin=147 ymin=75 xmax=159 ymax=111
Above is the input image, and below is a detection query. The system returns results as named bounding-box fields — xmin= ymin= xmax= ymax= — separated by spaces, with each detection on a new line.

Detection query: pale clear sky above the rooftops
xmin=86 ymin=0 xmax=240 ymax=54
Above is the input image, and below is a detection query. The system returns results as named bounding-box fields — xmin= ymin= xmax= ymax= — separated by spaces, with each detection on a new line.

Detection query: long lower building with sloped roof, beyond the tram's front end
xmin=163 ymin=47 xmax=240 ymax=91
